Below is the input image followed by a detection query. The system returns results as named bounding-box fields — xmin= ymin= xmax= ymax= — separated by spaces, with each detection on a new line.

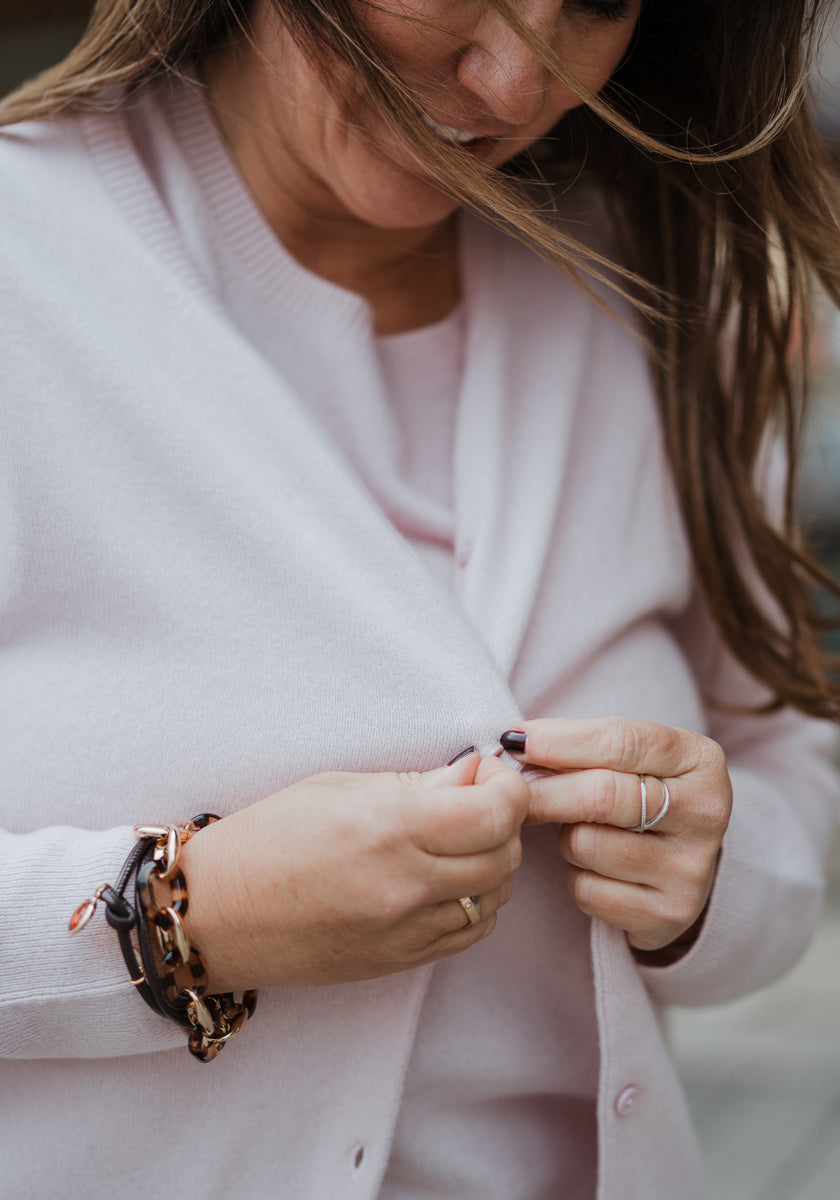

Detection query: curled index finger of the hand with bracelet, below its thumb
xmin=401 ymin=758 xmax=530 ymax=856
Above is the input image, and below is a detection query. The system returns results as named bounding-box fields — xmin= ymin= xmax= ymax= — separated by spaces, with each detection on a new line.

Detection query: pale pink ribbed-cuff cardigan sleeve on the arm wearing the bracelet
xmin=0 ymin=826 xmax=186 ymax=1058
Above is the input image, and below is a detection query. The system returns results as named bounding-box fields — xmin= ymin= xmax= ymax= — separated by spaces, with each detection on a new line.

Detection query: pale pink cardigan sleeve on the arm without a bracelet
xmin=640 ymin=585 xmax=839 ymax=1004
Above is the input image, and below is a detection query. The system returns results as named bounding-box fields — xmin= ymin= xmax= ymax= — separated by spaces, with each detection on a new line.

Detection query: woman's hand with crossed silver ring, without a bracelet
xmin=505 ymin=718 xmax=732 ymax=950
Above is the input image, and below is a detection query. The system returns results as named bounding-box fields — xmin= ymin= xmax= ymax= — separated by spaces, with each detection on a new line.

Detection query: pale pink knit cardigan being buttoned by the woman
xmin=0 ymin=77 xmax=835 ymax=1200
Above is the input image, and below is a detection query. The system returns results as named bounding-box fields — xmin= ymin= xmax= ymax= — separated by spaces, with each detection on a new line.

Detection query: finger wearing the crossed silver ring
xmin=527 ymin=768 xmax=676 ymax=834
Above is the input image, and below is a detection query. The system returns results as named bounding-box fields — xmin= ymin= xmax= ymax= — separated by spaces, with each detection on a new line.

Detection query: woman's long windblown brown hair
xmin=0 ymin=0 xmax=840 ymax=719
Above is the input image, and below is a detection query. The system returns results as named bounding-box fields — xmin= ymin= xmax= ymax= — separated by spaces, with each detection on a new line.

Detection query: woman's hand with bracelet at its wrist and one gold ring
xmin=181 ymin=754 xmax=530 ymax=992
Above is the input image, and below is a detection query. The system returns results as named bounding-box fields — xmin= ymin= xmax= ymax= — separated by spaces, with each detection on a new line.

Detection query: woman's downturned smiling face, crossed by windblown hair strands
xmin=205 ymin=0 xmax=632 ymax=239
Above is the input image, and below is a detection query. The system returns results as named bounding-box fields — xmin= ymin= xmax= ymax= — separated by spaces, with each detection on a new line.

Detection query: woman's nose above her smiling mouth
xmin=457 ymin=0 xmax=559 ymax=126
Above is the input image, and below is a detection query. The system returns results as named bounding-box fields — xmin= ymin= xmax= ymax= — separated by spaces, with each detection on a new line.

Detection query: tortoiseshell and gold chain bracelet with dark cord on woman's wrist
xmin=70 ymin=812 xmax=257 ymax=1062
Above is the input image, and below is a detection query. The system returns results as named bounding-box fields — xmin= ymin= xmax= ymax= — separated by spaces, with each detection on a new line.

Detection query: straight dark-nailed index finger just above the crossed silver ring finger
xmin=503 ymin=716 xmax=708 ymax=778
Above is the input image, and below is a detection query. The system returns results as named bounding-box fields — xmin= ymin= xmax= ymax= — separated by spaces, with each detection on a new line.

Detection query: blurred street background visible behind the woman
xmin=0 ymin=0 xmax=840 ymax=1200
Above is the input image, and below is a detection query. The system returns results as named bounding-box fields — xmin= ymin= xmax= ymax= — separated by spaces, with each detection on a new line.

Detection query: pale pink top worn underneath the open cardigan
xmin=374 ymin=321 xmax=598 ymax=1200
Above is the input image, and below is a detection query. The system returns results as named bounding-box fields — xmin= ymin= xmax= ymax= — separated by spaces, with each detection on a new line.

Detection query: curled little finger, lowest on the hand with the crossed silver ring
xmin=566 ymin=866 xmax=704 ymax=950
